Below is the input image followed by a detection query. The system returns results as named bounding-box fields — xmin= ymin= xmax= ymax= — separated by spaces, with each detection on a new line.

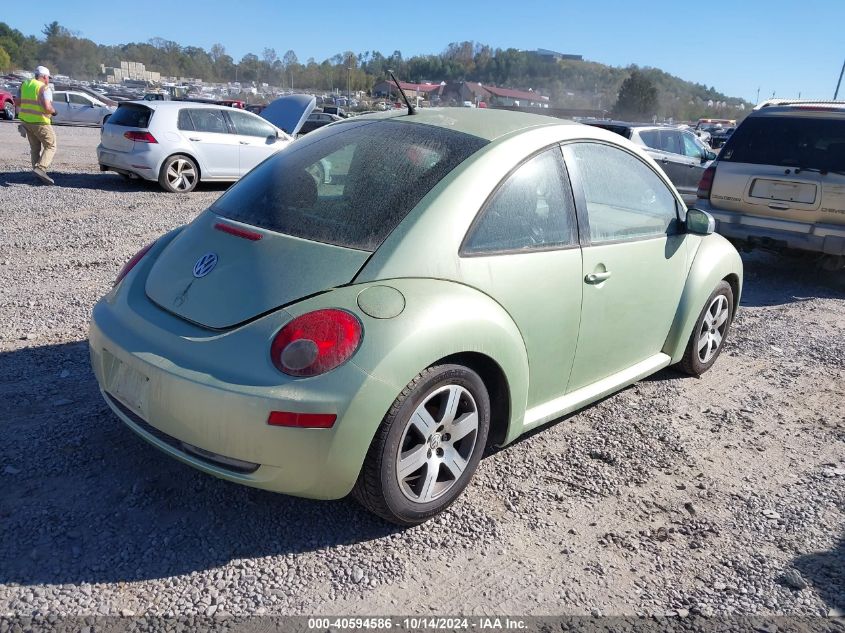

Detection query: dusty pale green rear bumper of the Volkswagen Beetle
xmin=88 ymin=263 xmax=398 ymax=499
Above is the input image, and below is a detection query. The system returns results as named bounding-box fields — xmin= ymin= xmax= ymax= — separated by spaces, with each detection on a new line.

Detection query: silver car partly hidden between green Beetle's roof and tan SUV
xmin=585 ymin=121 xmax=716 ymax=206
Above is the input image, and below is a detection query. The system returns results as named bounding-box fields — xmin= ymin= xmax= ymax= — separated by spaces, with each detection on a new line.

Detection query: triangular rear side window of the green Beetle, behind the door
xmin=461 ymin=147 xmax=578 ymax=255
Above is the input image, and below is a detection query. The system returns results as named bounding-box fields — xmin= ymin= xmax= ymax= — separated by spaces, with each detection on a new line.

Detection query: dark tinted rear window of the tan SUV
xmin=719 ymin=116 xmax=845 ymax=172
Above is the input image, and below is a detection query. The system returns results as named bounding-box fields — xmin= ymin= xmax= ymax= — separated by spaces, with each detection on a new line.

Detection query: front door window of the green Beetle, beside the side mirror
xmin=564 ymin=143 xmax=678 ymax=242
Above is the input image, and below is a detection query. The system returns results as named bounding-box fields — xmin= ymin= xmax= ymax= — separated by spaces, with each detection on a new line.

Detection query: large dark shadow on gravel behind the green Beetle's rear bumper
xmin=0 ymin=341 xmax=398 ymax=585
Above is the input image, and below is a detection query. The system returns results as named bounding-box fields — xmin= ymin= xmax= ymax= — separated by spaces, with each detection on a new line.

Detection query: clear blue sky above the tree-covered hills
xmin=0 ymin=0 xmax=845 ymax=102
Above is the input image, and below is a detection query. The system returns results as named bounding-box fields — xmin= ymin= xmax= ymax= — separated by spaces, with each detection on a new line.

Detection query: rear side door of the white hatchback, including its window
xmin=178 ymin=108 xmax=240 ymax=180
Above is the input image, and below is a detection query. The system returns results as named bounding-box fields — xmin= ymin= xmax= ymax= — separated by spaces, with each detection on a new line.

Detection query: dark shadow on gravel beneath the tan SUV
xmin=740 ymin=251 xmax=845 ymax=307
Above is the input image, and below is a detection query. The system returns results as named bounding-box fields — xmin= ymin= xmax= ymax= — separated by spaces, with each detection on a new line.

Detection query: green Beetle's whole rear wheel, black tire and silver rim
xmin=353 ymin=365 xmax=490 ymax=526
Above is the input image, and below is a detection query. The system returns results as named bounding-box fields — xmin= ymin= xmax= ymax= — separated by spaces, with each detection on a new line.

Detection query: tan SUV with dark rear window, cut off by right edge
xmin=697 ymin=100 xmax=845 ymax=269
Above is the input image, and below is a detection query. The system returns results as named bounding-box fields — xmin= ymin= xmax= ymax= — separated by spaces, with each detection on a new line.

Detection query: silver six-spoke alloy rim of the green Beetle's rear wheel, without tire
xmin=396 ymin=385 xmax=478 ymax=503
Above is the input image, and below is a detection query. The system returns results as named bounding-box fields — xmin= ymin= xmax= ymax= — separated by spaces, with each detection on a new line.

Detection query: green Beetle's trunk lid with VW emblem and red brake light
xmin=146 ymin=211 xmax=370 ymax=329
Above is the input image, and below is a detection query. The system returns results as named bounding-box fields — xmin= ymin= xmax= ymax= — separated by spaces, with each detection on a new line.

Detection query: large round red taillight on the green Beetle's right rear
xmin=270 ymin=309 xmax=363 ymax=377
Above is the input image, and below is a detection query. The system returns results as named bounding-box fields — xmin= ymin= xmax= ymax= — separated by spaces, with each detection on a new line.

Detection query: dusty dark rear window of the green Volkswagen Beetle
xmin=211 ymin=120 xmax=487 ymax=251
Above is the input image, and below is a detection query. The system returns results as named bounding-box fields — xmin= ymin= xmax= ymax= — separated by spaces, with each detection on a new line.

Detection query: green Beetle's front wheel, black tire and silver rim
xmin=678 ymin=280 xmax=734 ymax=376
